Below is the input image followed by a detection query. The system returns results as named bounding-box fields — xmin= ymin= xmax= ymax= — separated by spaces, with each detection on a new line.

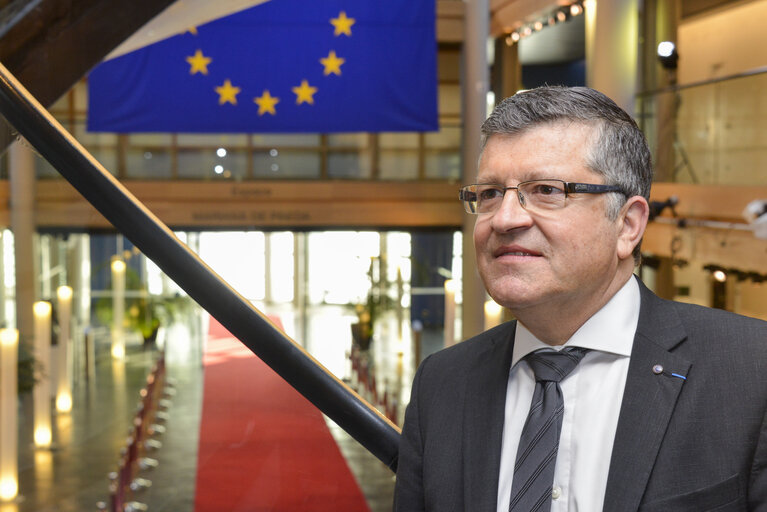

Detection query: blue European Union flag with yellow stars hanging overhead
xmin=88 ymin=0 xmax=437 ymax=133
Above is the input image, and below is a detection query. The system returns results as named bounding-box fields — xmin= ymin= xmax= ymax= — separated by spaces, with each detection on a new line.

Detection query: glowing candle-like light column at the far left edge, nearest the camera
xmin=0 ymin=329 xmax=19 ymax=501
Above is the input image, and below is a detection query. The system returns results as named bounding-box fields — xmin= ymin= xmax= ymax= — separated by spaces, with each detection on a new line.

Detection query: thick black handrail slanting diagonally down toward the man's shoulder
xmin=0 ymin=64 xmax=400 ymax=471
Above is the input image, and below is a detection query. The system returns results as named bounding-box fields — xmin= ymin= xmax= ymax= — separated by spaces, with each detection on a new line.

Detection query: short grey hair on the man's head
xmin=480 ymin=86 xmax=652 ymax=222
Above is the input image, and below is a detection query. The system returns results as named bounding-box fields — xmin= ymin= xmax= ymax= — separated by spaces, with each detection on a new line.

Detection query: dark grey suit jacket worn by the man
xmin=395 ymin=283 xmax=767 ymax=512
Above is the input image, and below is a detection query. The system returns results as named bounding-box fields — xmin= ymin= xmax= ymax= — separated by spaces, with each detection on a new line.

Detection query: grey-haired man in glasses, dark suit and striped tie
xmin=395 ymin=87 xmax=767 ymax=512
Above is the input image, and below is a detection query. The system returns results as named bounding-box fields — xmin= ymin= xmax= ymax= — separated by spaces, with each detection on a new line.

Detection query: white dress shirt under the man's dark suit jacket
xmin=498 ymin=277 xmax=640 ymax=512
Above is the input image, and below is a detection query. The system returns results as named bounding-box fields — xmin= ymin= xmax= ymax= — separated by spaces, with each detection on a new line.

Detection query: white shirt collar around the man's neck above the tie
xmin=511 ymin=277 xmax=640 ymax=367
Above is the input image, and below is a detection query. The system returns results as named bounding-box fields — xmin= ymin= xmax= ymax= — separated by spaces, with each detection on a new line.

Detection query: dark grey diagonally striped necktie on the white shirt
xmin=509 ymin=347 xmax=587 ymax=512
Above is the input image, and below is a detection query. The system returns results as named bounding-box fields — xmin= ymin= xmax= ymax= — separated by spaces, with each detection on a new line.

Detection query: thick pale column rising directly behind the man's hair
xmin=584 ymin=0 xmax=639 ymax=115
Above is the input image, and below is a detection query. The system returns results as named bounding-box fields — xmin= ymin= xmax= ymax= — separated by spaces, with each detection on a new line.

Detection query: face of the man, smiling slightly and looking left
xmin=474 ymin=122 xmax=625 ymax=321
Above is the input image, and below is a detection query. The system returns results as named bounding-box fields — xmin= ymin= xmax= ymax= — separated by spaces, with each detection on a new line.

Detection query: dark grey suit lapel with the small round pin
xmin=603 ymin=282 xmax=690 ymax=512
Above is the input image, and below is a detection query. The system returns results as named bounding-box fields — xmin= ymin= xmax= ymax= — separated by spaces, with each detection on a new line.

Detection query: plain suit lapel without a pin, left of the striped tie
xmin=463 ymin=322 xmax=516 ymax=512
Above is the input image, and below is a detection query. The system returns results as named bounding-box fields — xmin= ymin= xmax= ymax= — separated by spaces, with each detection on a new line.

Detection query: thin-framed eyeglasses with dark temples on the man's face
xmin=458 ymin=180 xmax=626 ymax=214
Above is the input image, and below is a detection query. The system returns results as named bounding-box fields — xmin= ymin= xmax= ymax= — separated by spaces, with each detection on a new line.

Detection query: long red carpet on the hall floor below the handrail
xmin=195 ymin=318 xmax=370 ymax=512
